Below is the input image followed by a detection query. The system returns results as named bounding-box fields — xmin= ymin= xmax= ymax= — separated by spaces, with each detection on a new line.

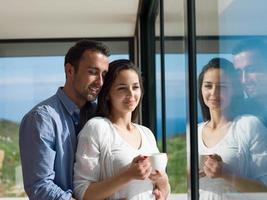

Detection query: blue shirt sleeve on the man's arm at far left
xmin=19 ymin=111 xmax=72 ymax=200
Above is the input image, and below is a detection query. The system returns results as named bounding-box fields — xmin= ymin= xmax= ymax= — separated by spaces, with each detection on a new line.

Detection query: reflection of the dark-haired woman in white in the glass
xmin=198 ymin=58 xmax=267 ymax=200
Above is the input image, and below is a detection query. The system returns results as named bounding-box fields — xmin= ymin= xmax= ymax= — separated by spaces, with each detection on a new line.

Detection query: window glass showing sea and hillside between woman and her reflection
xmin=156 ymin=53 xmax=187 ymax=193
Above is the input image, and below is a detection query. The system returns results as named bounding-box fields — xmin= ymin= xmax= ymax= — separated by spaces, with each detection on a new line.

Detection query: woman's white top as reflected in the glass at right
xmin=198 ymin=115 xmax=267 ymax=200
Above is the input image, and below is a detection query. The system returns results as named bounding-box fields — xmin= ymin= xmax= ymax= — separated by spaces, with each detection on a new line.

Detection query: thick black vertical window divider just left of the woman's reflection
xmin=184 ymin=0 xmax=199 ymax=200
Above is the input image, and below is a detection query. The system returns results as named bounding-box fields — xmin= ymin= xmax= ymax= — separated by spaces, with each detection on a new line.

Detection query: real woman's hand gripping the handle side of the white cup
xmin=127 ymin=155 xmax=152 ymax=180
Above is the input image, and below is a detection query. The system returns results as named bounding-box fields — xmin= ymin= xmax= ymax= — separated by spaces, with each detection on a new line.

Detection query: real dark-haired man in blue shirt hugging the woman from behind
xmin=19 ymin=40 xmax=109 ymax=200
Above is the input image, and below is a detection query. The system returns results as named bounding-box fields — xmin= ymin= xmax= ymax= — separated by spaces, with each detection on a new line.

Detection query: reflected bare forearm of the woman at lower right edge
xmin=223 ymin=175 xmax=267 ymax=192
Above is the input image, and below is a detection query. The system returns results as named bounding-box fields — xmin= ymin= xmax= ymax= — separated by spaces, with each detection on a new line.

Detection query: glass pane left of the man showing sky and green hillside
xmin=0 ymin=56 xmax=65 ymax=196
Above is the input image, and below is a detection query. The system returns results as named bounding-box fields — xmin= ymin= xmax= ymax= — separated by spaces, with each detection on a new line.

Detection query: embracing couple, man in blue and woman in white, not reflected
xmin=19 ymin=40 xmax=169 ymax=200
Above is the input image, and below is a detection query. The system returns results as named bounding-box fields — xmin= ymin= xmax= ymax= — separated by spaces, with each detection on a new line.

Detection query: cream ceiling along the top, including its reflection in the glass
xmin=0 ymin=0 xmax=267 ymax=39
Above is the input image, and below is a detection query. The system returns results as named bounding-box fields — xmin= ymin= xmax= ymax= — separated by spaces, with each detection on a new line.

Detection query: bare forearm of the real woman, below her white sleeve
xmin=83 ymin=172 xmax=131 ymax=200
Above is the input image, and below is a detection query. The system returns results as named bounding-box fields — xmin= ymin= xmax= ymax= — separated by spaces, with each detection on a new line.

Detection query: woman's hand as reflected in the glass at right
xmin=203 ymin=154 xmax=223 ymax=178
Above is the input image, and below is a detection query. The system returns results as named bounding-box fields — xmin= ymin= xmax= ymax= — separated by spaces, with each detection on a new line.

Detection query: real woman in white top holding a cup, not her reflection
xmin=74 ymin=60 xmax=169 ymax=200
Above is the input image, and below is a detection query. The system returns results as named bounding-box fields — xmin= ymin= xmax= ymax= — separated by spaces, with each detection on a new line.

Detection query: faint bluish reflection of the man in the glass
xmin=233 ymin=39 xmax=267 ymax=126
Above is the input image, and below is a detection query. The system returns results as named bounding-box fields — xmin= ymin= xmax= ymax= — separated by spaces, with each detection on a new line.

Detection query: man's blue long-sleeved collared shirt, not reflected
xmin=19 ymin=88 xmax=80 ymax=200
